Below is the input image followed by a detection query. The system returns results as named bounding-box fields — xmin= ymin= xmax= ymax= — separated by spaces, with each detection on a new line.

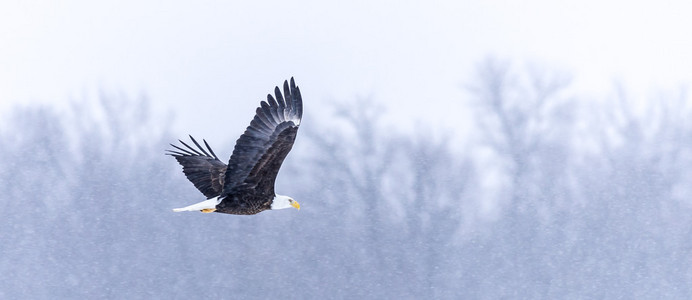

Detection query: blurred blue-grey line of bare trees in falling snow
xmin=0 ymin=61 xmax=692 ymax=299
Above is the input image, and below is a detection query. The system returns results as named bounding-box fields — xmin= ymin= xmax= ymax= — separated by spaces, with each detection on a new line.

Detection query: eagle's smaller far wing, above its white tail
xmin=166 ymin=136 xmax=226 ymax=199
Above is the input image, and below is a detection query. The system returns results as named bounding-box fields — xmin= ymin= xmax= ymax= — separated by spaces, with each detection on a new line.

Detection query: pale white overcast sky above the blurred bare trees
xmin=0 ymin=0 xmax=692 ymax=140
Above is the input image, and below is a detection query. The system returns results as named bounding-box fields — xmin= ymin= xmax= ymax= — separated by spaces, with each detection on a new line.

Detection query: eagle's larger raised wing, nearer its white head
xmin=221 ymin=78 xmax=303 ymax=197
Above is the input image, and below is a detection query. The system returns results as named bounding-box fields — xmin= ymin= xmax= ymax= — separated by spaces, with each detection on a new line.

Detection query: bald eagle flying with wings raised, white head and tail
xmin=166 ymin=78 xmax=303 ymax=215
